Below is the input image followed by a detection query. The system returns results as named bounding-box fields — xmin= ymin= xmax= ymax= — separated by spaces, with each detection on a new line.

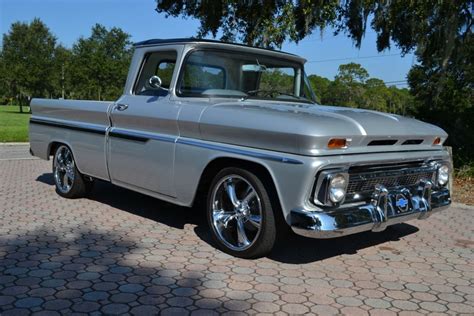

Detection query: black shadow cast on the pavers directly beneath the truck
xmin=36 ymin=173 xmax=418 ymax=264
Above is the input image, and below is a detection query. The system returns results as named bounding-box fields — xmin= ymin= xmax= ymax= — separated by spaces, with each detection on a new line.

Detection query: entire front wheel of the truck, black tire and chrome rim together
xmin=207 ymin=168 xmax=276 ymax=258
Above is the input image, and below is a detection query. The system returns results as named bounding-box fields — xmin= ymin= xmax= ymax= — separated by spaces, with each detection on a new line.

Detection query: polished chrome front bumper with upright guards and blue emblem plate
xmin=290 ymin=181 xmax=451 ymax=239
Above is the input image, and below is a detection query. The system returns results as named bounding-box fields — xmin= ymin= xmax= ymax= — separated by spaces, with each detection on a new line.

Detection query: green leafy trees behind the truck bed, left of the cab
xmin=0 ymin=19 xmax=132 ymax=102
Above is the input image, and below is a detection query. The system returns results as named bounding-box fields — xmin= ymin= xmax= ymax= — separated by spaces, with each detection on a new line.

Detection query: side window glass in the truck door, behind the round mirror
xmin=133 ymin=51 xmax=177 ymax=96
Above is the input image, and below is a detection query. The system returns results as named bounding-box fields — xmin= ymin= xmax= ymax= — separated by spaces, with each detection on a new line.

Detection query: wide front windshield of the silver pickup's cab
xmin=177 ymin=50 xmax=315 ymax=103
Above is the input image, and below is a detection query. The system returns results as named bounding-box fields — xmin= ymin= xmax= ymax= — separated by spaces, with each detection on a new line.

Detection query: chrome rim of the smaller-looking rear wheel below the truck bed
xmin=53 ymin=146 xmax=75 ymax=193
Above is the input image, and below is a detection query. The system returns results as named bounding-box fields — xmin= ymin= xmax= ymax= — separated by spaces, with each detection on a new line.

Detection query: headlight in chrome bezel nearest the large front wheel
xmin=313 ymin=170 xmax=349 ymax=207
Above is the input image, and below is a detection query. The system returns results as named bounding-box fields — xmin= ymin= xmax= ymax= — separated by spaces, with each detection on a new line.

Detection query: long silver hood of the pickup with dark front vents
xmin=200 ymin=100 xmax=447 ymax=156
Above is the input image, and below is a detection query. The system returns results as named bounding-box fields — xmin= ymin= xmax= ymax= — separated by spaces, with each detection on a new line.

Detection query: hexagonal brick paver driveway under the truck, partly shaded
xmin=0 ymin=148 xmax=474 ymax=315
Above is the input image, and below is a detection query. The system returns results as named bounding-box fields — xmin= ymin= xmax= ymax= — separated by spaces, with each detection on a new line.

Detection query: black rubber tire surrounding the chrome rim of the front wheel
xmin=206 ymin=167 xmax=276 ymax=259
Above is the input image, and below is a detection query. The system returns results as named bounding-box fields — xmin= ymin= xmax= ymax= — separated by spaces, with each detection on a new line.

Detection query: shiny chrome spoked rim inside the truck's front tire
xmin=211 ymin=174 xmax=262 ymax=251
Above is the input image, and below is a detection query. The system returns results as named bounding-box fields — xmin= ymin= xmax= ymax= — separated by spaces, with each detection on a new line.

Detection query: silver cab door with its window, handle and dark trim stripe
xmin=108 ymin=48 xmax=180 ymax=196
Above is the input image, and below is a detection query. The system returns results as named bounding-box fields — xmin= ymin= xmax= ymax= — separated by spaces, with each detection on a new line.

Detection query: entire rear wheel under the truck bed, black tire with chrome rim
xmin=52 ymin=145 xmax=94 ymax=199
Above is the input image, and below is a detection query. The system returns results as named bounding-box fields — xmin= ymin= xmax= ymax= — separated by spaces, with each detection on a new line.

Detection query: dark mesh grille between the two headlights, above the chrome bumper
xmin=347 ymin=167 xmax=435 ymax=194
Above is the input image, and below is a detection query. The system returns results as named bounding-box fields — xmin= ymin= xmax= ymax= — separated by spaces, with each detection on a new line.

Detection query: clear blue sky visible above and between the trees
xmin=0 ymin=0 xmax=415 ymax=87
